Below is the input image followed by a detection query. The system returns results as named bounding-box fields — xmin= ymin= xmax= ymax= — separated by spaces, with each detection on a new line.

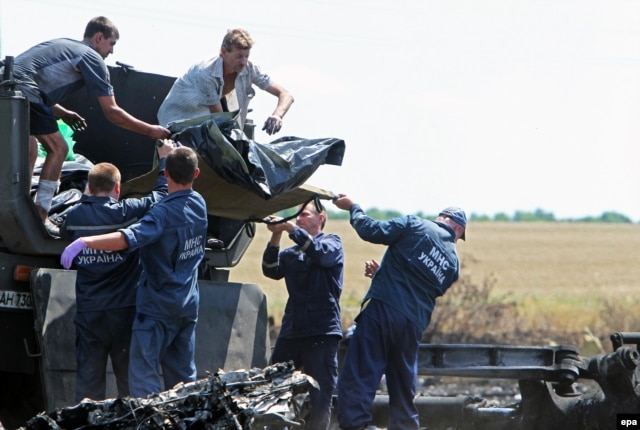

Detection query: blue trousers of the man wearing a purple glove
xmin=129 ymin=313 xmax=198 ymax=397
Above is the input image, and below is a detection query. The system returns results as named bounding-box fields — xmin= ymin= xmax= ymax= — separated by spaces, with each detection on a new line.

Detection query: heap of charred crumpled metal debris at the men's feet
xmin=23 ymin=362 xmax=317 ymax=430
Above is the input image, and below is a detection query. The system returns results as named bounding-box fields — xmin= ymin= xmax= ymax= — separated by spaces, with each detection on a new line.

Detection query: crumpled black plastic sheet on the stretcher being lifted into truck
xmin=170 ymin=112 xmax=345 ymax=200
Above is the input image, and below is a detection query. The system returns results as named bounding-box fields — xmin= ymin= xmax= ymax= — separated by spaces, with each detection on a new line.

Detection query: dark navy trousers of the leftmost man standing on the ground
xmin=74 ymin=306 xmax=136 ymax=402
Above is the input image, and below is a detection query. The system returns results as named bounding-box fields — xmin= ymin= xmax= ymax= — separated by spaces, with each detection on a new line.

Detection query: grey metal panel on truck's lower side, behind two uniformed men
xmin=31 ymin=269 xmax=270 ymax=411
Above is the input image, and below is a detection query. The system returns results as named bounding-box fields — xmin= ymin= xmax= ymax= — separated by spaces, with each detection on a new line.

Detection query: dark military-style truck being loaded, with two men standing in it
xmin=0 ymin=57 xmax=340 ymax=428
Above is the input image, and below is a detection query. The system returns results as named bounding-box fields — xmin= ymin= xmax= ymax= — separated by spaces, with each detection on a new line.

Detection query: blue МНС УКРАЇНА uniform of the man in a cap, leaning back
xmin=338 ymin=205 xmax=460 ymax=430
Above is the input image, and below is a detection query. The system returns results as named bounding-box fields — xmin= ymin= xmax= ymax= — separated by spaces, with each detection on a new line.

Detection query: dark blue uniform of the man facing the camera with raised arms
xmin=262 ymin=226 xmax=344 ymax=430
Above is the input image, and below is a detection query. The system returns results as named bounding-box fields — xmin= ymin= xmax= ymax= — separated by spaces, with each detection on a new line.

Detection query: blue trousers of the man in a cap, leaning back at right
xmin=338 ymin=300 xmax=422 ymax=430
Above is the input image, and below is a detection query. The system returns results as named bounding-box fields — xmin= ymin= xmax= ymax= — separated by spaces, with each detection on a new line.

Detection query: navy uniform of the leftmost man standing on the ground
xmin=60 ymin=159 xmax=167 ymax=402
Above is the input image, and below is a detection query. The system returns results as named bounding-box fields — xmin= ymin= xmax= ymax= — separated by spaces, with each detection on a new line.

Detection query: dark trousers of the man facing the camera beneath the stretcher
xmin=271 ymin=336 xmax=340 ymax=430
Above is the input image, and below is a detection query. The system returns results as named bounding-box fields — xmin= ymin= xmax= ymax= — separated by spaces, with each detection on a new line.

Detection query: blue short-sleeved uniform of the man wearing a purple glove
xmin=119 ymin=189 xmax=207 ymax=397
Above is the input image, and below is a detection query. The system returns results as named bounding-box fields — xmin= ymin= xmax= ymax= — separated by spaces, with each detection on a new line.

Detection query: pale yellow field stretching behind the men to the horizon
xmin=230 ymin=220 xmax=640 ymax=332
